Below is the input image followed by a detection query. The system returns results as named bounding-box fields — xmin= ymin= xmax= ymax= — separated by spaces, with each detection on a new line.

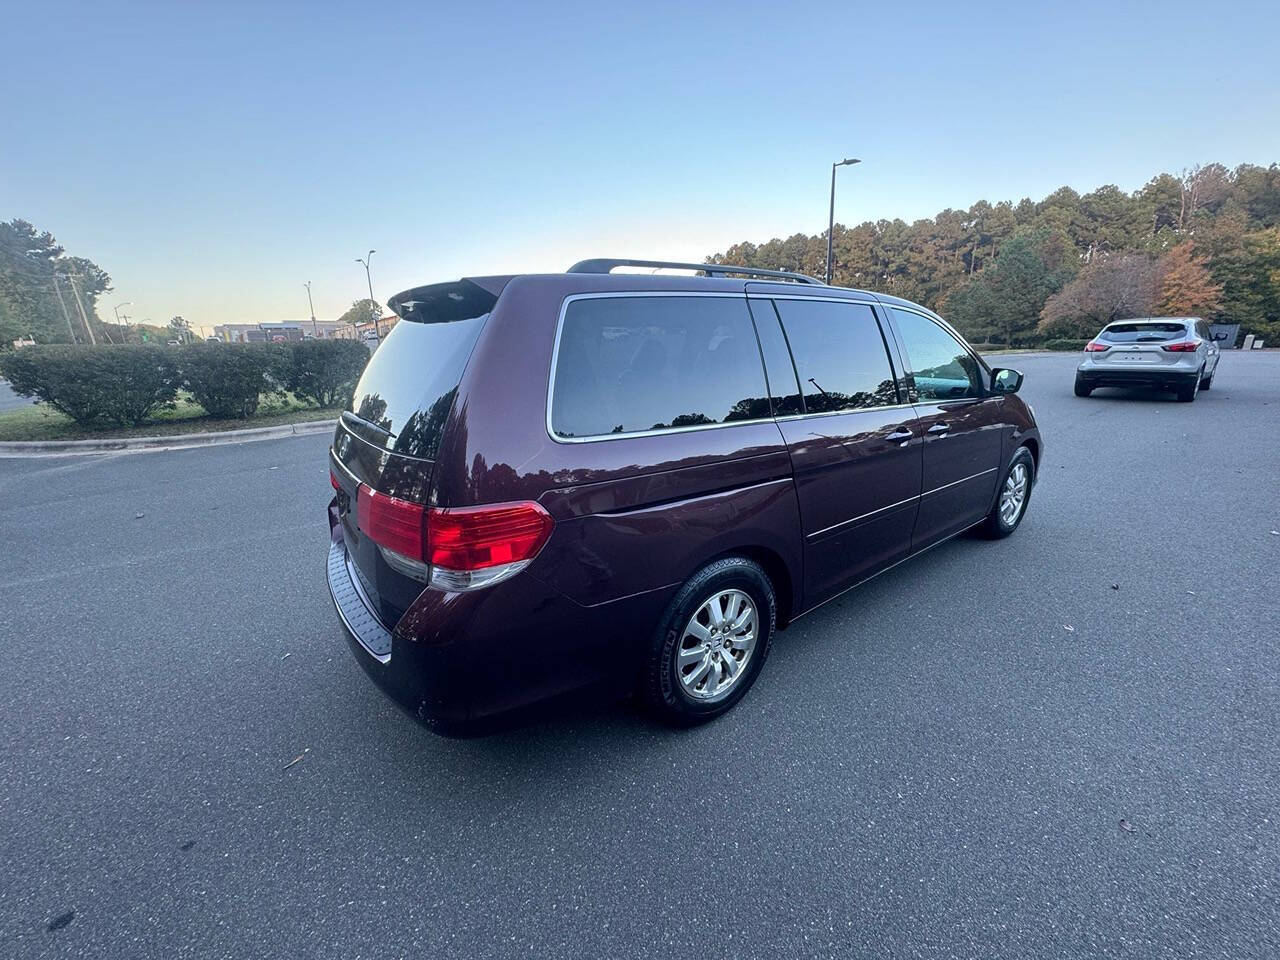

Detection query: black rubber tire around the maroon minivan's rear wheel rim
xmin=640 ymin=557 xmax=778 ymax=727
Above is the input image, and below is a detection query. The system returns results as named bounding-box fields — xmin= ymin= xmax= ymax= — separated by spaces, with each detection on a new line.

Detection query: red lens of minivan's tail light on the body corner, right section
xmin=426 ymin=500 xmax=556 ymax=570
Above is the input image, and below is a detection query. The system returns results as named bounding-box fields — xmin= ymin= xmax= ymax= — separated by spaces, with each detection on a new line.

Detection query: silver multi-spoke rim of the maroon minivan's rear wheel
xmin=676 ymin=590 xmax=759 ymax=701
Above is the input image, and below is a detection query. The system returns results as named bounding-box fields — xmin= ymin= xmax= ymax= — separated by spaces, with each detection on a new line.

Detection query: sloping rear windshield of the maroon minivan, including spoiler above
xmin=347 ymin=280 xmax=498 ymax=460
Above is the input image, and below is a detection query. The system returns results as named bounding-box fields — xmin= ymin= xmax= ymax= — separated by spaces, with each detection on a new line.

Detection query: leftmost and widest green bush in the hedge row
xmin=0 ymin=344 xmax=180 ymax=426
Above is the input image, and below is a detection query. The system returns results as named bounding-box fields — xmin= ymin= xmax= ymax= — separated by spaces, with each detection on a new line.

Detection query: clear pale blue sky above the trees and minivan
xmin=0 ymin=0 xmax=1280 ymax=325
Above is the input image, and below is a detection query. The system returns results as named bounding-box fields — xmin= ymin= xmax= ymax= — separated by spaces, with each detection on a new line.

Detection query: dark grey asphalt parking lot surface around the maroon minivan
xmin=0 ymin=352 xmax=1280 ymax=959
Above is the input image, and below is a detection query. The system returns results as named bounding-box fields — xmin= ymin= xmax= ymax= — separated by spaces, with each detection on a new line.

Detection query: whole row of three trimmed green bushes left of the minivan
xmin=0 ymin=340 xmax=369 ymax=426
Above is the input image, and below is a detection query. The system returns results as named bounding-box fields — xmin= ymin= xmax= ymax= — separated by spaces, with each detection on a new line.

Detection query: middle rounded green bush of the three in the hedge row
xmin=175 ymin=343 xmax=287 ymax=420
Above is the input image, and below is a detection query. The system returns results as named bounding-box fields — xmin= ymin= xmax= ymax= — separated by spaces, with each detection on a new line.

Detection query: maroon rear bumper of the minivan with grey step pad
xmin=328 ymin=519 xmax=677 ymax=736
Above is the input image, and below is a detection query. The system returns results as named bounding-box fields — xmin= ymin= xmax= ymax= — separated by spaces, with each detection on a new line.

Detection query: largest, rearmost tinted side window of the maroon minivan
xmin=552 ymin=296 xmax=771 ymax=436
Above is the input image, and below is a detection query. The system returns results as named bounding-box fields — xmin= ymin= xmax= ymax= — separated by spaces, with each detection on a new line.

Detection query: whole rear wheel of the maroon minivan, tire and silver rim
xmin=643 ymin=557 xmax=777 ymax=726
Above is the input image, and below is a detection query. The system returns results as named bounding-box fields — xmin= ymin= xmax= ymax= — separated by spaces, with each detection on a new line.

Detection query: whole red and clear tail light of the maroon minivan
xmin=356 ymin=484 xmax=556 ymax=590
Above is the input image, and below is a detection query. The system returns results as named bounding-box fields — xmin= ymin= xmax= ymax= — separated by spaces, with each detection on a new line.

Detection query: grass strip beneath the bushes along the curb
xmin=0 ymin=393 xmax=342 ymax=442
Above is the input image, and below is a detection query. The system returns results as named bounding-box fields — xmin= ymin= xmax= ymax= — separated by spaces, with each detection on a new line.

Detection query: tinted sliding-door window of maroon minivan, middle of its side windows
xmin=776 ymin=300 xmax=897 ymax=413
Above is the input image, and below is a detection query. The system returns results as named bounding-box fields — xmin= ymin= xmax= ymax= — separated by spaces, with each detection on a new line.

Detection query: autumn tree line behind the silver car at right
xmin=708 ymin=164 xmax=1280 ymax=346
